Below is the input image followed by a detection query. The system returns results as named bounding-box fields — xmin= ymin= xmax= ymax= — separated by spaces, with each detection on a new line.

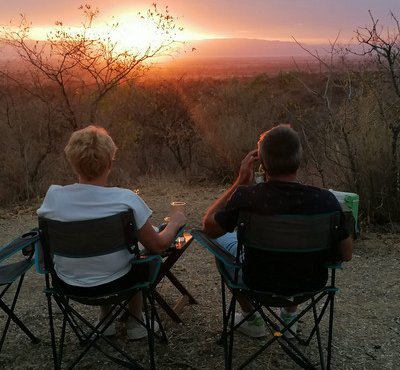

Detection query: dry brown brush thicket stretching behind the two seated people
xmin=0 ymin=69 xmax=400 ymax=222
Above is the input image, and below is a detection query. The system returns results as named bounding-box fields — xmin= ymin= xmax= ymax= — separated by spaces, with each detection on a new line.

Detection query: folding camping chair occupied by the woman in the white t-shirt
xmin=39 ymin=211 xmax=167 ymax=369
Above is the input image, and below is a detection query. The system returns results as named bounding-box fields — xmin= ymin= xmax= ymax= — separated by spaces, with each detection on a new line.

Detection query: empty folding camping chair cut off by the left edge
xmin=0 ymin=232 xmax=39 ymax=352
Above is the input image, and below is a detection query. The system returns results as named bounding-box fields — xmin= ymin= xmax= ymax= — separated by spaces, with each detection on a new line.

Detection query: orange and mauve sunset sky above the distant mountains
xmin=0 ymin=0 xmax=400 ymax=43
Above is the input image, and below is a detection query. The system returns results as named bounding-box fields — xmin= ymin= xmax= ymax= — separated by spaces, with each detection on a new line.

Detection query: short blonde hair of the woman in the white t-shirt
xmin=64 ymin=125 xmax=117 ymax=180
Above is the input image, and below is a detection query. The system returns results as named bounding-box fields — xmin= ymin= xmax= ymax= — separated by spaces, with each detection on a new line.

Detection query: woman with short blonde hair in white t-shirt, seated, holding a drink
xmin=37 ymin=125 xmax=185 ymax=339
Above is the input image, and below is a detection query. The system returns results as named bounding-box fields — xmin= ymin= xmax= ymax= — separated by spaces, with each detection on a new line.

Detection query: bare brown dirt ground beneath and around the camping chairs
xmin=0 ymin=180 xmax=400 ymax=370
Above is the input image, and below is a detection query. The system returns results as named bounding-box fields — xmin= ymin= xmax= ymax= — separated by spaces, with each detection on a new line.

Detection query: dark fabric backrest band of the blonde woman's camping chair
xmin=39 ymin=211 xmax=138 ymax=271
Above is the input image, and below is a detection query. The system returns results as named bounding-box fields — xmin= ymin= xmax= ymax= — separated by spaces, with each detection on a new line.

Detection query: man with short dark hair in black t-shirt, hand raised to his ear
xmin=203 ymin=124 xmax=353 ymax=337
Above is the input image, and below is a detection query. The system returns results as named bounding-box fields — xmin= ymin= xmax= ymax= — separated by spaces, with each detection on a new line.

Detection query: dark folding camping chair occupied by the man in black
xmin=191 ymin=212 xmax=346 ymax=369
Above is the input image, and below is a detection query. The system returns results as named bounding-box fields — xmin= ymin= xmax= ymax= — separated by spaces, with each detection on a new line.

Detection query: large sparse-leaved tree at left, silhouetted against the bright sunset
xmin=0 ymin=4 xmax=182 ymax=199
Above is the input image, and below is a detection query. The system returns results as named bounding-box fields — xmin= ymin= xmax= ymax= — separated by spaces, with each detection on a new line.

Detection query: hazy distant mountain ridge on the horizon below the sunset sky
xmin=0 ymin=39 xmax=362 ymax=78
